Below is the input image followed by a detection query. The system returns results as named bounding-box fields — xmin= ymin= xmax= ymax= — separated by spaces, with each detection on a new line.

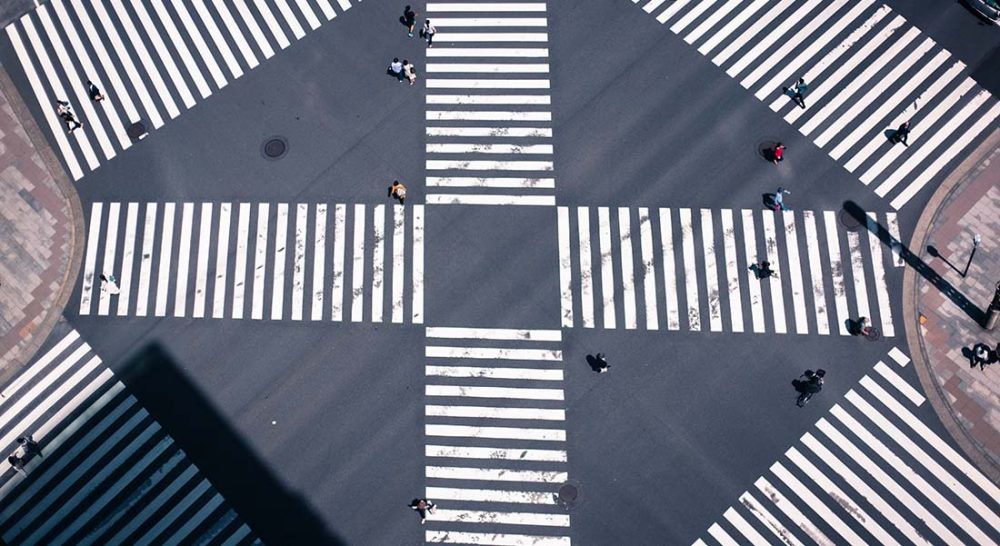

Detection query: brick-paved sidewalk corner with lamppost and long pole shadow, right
xmin=903 ymin=130 xmax=1000 ymax=482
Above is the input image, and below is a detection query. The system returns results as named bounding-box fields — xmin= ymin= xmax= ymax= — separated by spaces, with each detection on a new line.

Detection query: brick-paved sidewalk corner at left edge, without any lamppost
xmin=0 ymin=68 xmax=83 ymax=383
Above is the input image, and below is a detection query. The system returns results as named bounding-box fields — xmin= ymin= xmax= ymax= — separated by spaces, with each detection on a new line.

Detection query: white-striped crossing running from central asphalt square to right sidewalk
xmin=557 ymin=206 xmax=903 ymax=337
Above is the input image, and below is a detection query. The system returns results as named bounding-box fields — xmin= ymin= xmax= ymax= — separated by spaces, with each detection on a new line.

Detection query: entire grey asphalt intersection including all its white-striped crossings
xmin=0 ymin=0 xmax=1000 ymax=546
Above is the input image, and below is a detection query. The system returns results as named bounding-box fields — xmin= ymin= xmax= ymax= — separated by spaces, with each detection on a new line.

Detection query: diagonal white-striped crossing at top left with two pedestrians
xmin=6 ymin=0 xmax=351 ymax=180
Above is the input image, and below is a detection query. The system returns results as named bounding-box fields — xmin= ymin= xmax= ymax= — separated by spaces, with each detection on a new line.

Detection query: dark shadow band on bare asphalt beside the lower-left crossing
xmin=120 ymin=343 xmax=346 ymax=546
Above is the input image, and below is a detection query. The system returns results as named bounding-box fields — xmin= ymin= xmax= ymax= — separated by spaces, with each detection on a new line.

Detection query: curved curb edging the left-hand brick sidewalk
xmin=0 ymin=66 xmax=84 ymax=384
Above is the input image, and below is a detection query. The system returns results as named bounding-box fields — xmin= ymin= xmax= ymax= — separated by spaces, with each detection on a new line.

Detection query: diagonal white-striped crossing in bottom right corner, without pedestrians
xmin=694 ymin=348 xmax=1000 ymax=546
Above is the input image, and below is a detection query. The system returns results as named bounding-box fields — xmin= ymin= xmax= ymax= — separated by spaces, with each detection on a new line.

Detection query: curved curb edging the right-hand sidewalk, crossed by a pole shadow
xmin=903 ymin=124 xmax=1000 ymax=483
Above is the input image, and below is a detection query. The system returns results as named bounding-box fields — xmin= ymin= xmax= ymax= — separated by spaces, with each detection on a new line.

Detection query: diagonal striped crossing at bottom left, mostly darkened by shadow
xmin=0 ymin=330 xmax=261 ymax=546
